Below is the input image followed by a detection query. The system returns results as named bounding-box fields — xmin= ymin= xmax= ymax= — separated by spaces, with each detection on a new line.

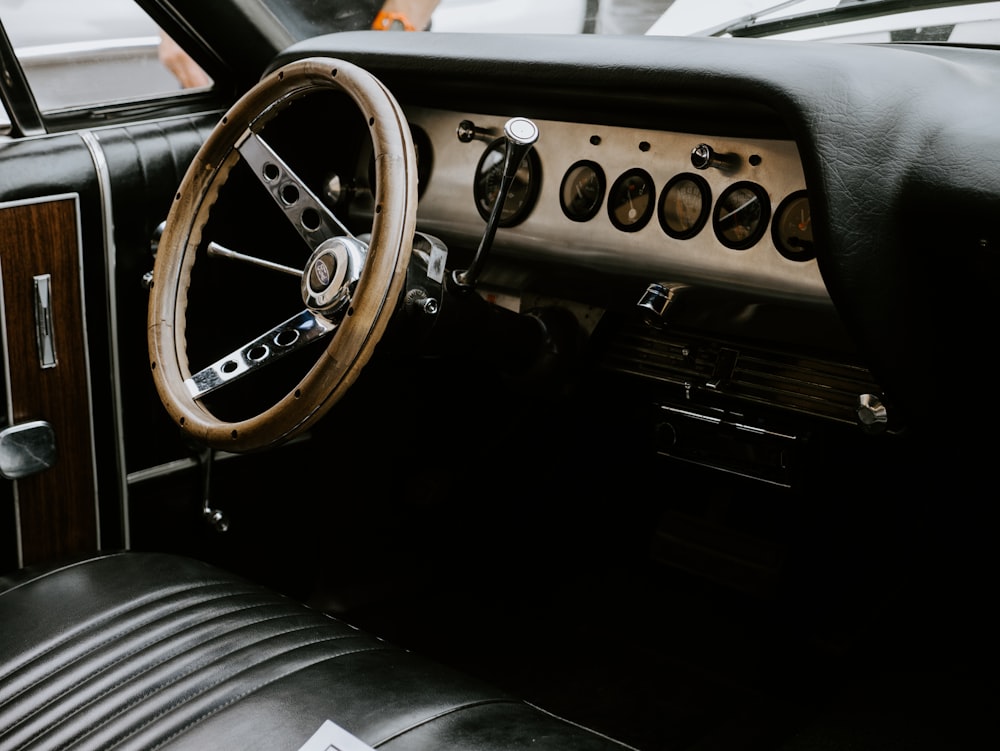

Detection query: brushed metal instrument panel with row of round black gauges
xmin=398 ymin=108 xmax=827 ymax=301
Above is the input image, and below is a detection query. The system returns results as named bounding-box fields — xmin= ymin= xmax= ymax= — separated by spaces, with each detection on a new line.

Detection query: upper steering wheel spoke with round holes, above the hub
xmin=236 ymin=129 xmax=354 ymax=251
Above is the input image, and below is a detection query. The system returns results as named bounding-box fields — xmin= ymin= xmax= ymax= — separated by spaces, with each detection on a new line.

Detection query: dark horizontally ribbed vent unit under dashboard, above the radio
xmin=598 ymin=318 xmax=880 ymax=425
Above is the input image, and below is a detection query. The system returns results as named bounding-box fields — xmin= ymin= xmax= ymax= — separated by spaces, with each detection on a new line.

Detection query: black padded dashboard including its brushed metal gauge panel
xmin=272 ymin=32 xmax=1000 ymax=440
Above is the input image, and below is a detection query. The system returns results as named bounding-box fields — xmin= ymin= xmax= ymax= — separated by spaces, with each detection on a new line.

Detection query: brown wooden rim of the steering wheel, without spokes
xmin=148 ymin=58 xmax=417 ymax=452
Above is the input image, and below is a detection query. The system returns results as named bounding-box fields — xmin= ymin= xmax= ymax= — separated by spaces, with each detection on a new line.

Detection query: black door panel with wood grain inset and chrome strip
xmin=0 ymin=112 xmax=218 ymax=570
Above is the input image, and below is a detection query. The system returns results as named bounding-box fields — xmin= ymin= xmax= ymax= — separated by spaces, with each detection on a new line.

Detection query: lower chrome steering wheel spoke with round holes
xmin=184 ymin=310 xmax=337 ymax=400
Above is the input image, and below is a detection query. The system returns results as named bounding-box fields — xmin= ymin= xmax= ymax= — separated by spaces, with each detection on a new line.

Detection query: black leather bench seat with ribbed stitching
xmin=0 ymin=553 xmax=624 ymax=751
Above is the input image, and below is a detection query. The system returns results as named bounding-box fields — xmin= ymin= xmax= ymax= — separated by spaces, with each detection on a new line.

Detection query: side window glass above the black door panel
xmin=0 ymin=0 xmax=209 ymax=119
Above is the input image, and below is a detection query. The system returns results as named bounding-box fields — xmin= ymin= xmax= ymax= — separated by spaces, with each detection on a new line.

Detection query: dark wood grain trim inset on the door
xmin=0 ymin=194 xmax=100 ymax=565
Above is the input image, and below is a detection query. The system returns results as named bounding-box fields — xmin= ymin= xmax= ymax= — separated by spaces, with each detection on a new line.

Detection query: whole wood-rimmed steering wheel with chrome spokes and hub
xmin=148 ymin=58 xmax=417 ymax=452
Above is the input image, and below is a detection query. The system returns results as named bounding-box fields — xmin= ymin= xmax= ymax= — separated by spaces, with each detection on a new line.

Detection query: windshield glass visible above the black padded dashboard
xmin=236 ymin=0 xmax=1000 ymax=45
